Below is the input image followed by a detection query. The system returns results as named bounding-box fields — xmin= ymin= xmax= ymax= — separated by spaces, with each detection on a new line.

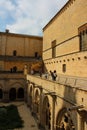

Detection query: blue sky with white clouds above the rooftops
xmin=0 ymin=0 xmax=68 ymax=36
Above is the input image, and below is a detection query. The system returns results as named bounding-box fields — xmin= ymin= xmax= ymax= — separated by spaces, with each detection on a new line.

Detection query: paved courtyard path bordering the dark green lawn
xmin=0 ymin=102 xmax=39 ymax=130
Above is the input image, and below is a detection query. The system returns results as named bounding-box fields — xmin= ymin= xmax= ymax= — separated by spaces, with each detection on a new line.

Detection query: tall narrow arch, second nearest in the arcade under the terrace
xmin=42 ymin=96 xmax=51 ymax=130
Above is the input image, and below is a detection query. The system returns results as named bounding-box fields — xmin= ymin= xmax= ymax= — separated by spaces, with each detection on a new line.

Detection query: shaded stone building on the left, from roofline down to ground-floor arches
xmin=0 ymin=30 xmax=43 ymax=102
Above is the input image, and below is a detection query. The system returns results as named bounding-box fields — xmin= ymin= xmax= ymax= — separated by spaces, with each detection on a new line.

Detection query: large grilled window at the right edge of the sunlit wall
xmin=79 ymin=24 xmax=87 ymax=51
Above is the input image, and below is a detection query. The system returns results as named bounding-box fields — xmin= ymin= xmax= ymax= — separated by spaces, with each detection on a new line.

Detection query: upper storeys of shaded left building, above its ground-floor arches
xmin=0 ymin=30 xmax=42 ymax=72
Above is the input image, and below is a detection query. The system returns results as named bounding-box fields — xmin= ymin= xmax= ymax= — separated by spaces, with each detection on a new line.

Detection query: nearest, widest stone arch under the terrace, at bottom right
xmin=56 ymin=108 xmax=75 ymax=130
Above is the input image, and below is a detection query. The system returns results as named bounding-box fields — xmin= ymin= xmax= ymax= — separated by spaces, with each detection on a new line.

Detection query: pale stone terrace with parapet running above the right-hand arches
xmin=27 ymin=74 xmax=87 ymax=92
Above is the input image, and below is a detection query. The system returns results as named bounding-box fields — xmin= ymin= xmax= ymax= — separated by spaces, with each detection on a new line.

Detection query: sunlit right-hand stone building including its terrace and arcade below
xmin=26 ymin=0 xmax=87 ymax=130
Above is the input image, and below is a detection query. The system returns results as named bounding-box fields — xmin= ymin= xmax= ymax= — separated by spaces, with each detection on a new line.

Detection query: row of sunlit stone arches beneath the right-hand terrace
xmin=27 ymin=83 xmax=76 ymax=130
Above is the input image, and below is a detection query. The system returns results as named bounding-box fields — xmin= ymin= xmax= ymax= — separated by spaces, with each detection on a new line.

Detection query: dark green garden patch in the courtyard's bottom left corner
xmin=0 ymin=105 xmax=24 ymax=130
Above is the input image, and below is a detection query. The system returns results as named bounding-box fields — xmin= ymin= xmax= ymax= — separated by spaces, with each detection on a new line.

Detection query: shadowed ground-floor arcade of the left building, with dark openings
xmin=0 ymin=82 xmax=25 ymax=102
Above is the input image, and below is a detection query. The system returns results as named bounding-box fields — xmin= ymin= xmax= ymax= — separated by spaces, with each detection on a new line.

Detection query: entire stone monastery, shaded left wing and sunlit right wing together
xmin=0 ymin=0 xmax=87 ymax=130
